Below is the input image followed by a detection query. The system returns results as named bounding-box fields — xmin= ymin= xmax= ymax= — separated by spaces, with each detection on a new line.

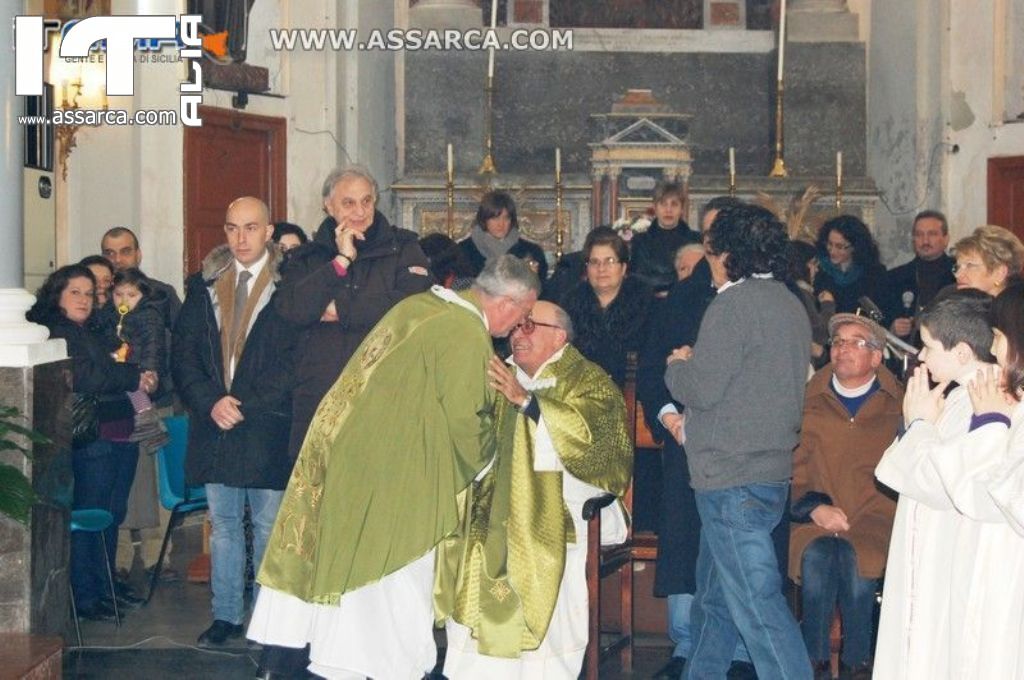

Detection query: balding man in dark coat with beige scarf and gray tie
xmin=172 ymin=197 xmax=295 ymax=647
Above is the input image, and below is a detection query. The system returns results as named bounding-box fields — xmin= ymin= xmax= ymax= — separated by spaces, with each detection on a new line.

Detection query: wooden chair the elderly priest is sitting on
xmin=583 ymin=353 xmax=659 ymax=680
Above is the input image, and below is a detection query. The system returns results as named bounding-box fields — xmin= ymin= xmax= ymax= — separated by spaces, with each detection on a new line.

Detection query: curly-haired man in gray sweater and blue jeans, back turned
xmin=665 ymin=205 xmax=811 ymax=680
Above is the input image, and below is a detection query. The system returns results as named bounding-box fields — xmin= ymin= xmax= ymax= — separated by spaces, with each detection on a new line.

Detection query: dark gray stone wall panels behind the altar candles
xmin=404 ymin=43 xmax=865 ymax=183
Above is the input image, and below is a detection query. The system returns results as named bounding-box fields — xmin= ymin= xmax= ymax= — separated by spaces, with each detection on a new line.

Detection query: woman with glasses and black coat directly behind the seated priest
xmin=562 ymin=226 xmax=653 ymax=387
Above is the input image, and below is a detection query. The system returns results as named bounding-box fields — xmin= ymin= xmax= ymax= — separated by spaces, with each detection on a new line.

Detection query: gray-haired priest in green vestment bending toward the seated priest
xmin=248 ymin=256 xmax=540 ymax=679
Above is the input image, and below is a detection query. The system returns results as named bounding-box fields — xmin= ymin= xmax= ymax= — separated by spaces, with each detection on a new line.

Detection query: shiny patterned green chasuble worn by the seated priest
xmin=434 ymin=345 xmax=633 ymax=657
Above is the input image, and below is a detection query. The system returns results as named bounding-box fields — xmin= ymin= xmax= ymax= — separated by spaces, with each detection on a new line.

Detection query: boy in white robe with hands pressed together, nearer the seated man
xmin=874 ymin=289 xmax=993 ymax=680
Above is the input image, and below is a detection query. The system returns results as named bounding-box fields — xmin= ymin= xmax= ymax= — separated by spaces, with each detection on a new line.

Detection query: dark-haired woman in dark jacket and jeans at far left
xmin=25 ymin=264 xmax=157 ymax=619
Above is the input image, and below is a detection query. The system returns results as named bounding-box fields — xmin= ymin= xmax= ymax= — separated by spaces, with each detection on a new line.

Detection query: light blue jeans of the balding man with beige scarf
xmin=206 ymin=484 xmax=285 ymax=624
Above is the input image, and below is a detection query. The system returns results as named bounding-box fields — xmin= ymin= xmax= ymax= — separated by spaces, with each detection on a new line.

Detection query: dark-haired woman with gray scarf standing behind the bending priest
xmin=459 ymin=192 xmax=548 ymax=285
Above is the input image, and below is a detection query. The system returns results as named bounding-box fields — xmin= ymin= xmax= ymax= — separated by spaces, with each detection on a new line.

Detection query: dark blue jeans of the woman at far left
xmin=71 ymin=439 xmax=138 ymax=608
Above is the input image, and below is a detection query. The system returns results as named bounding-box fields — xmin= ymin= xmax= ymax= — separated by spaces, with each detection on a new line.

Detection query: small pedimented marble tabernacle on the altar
xmin=590 ymin=90 xmax=693 ymax=223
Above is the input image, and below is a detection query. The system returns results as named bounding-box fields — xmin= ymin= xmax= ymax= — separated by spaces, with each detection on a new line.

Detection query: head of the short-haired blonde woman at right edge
xmin=953 ymin=224 xmax=1024 ymax=297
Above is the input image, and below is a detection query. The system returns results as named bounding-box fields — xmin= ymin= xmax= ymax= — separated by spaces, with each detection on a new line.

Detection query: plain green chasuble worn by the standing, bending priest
xmin=258 ymin=287 xmax=495 ymax=604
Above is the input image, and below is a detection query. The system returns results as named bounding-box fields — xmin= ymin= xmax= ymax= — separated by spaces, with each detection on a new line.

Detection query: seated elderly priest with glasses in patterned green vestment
xmin=434 ymin=302 xmax=633 ymax=680
